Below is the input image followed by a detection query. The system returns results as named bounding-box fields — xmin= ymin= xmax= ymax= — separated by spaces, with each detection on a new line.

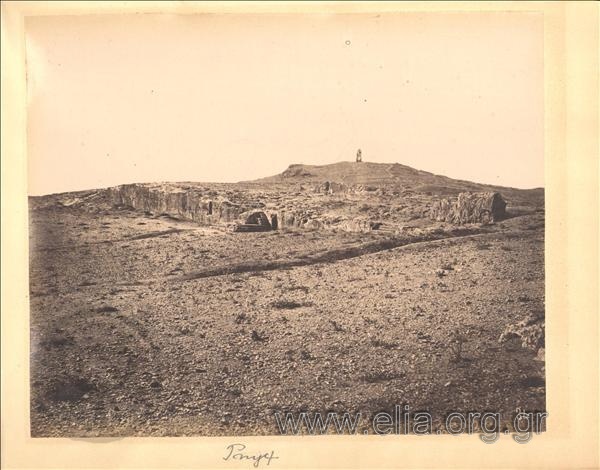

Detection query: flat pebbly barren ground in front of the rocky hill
xmin=30 ymin=200 xmax=545 ymax=436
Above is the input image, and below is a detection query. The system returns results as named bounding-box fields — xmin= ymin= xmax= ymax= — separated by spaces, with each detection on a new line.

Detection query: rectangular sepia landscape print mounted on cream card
xmin=25 ymin=12 xmax=547 ymax=438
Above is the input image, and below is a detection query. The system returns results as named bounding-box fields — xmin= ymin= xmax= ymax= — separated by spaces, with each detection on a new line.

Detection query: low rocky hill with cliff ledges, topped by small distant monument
xmin=31 ymin=162 xmax=544 ymax=233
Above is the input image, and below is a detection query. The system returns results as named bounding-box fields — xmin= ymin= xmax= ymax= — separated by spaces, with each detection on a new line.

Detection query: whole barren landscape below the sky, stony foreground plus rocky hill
xmin=29 ymin=163 xmax=545 ymax=438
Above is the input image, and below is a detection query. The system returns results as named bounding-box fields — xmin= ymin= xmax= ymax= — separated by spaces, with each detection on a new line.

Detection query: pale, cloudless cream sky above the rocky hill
xmin=26 ymin=13 xmax=544 ymax=195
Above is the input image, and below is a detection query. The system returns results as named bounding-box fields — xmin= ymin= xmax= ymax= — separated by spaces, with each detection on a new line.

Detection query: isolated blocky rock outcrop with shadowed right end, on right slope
xmin=429 ymin=192 xmax=506 ymax=225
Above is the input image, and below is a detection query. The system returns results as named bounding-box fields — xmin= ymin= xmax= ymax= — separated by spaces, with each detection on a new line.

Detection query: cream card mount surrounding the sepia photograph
xmin=1 ymin=2 xmax=599 ymax=468
